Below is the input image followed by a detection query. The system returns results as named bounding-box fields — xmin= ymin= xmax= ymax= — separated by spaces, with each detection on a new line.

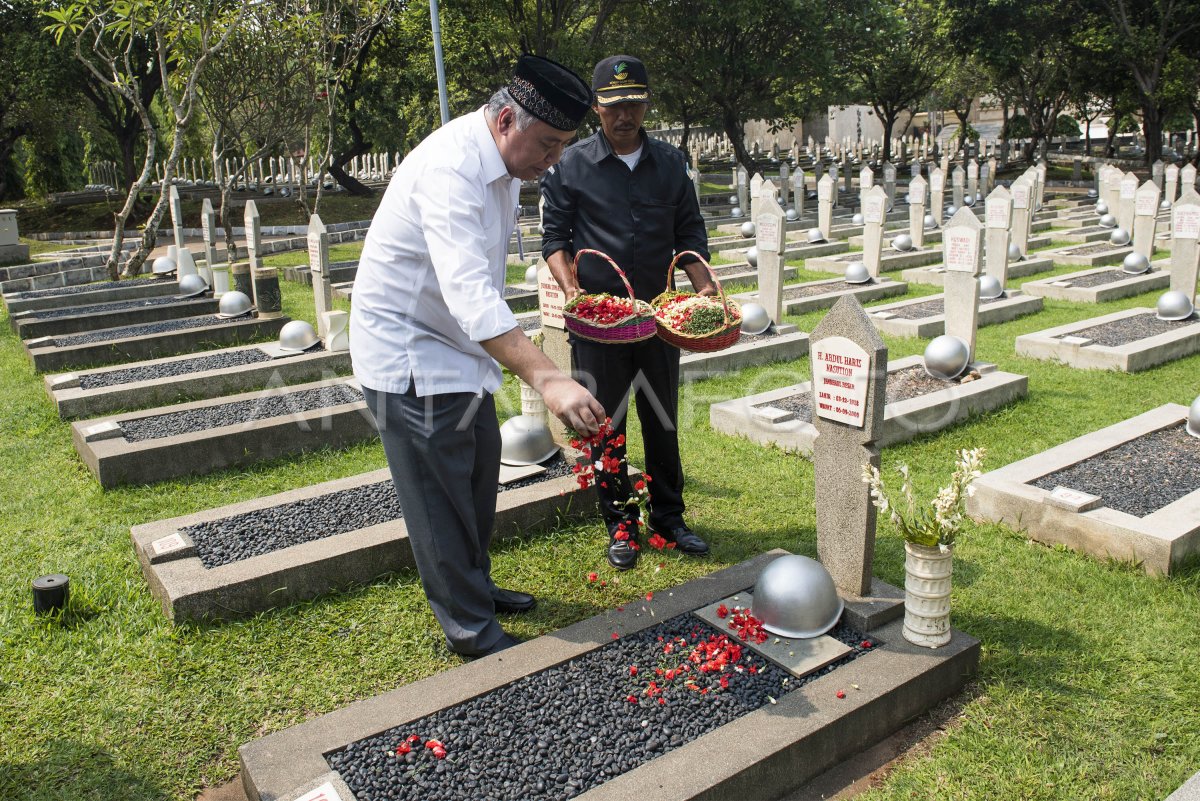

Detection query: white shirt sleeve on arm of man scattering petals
xmin=414 ymin=168 xmax=517 ymax=342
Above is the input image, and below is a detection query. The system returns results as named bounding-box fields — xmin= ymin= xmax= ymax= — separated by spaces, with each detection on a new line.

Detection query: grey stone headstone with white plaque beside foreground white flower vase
xmin=811 ymin=295 xmax=888 ymax=596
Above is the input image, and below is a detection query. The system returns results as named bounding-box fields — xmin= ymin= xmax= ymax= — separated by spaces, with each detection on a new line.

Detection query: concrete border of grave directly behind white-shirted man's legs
xmin=130 ymin=455 xmax=609 ymax=622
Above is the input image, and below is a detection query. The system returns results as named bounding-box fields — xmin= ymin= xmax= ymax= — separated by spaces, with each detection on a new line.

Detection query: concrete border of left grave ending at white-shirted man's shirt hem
xmin=43 ymin=342 xmax=350 ymax=420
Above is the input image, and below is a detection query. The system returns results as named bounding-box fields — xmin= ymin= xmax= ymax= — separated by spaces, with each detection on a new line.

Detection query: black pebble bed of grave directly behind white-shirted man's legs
xmin=181 ymin=454 xmax=571 ymax=570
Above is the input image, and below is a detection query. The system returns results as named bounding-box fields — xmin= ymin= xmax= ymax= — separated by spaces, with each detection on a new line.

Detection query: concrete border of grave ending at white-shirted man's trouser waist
xmin=71 ymin=379 xmax=377 ymax=489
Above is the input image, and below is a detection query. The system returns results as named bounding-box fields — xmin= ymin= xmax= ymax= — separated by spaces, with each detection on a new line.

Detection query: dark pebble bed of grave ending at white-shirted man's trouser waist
xmin=121 ymin=384 xmax=362 ymax=442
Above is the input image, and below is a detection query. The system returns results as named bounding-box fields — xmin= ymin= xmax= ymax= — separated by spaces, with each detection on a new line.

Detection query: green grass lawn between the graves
xmin=0 ymin=230 xmax=1200 ymax=801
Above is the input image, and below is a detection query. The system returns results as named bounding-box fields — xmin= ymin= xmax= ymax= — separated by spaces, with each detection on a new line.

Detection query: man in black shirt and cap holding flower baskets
xmin=541 ymin=55 xmax=715 ymax=570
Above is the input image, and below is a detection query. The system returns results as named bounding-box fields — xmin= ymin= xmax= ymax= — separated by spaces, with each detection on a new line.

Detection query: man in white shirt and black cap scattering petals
xmin=350 ymin=55 xmax=605 ymax=657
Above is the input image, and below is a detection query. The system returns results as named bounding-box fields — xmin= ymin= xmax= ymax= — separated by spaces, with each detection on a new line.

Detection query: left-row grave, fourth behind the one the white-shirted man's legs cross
xmin=8 ymin=296 xmax=218 ymax=339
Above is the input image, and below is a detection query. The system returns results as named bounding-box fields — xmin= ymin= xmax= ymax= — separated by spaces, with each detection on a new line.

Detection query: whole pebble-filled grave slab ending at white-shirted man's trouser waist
xmin=71 ymin=379 xmax=377 ymax=489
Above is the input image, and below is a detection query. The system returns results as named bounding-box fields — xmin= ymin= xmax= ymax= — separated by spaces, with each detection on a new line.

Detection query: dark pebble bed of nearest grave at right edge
xmin=1028 ymin=423 xmax=1200 ymax=517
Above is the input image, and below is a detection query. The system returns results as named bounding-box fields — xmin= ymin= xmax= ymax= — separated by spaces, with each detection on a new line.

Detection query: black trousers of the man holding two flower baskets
xmin=571 ymin=337 xmax=684 ymax=531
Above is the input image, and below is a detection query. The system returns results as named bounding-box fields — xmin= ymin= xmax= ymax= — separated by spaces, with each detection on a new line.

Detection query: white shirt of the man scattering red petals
xmin=350 ymin=109 xmax=521 ymax=397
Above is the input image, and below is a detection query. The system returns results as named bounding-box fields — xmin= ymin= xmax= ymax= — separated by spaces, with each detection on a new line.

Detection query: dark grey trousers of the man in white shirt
xmin=362 ymin=387 xmax=504 ymax=655
